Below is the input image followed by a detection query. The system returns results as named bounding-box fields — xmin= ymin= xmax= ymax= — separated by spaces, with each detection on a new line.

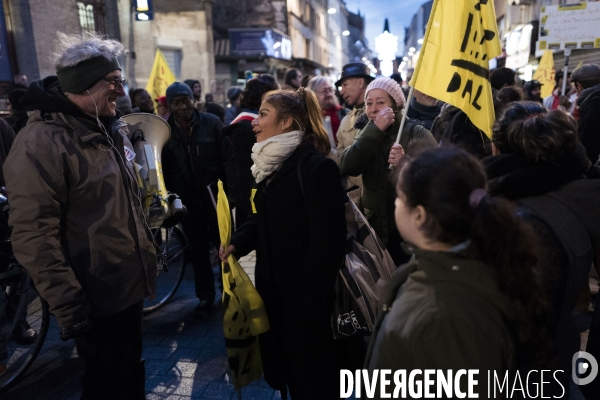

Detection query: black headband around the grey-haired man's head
xmin=56 ymin=56 xmax=121 ymax=94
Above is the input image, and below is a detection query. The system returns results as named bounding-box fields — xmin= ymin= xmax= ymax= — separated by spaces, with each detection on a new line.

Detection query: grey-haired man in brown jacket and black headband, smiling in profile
xmin=4 ymin=34 xmax=157 ymax=400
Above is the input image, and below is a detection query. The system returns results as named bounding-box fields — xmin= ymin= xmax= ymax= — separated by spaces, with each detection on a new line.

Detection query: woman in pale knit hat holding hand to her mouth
xmin=339 ymin=78 xmax=437 ymax=265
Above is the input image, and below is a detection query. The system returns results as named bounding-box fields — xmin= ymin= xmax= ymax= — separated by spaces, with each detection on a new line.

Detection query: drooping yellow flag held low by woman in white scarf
xmin=217 ymin=181 xmax=269 ymax=389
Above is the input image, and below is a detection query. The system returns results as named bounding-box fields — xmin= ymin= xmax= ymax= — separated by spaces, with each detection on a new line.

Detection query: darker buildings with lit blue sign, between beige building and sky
xmin=213 ymin=0 xmax=367 ymax=99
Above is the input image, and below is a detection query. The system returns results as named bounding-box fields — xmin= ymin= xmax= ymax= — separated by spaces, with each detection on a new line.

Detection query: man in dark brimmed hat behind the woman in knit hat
xmin=335 ymin=63 xmax=375 ymax=187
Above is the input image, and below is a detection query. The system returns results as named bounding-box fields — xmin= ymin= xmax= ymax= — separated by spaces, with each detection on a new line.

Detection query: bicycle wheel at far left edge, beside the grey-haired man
xmin=0 ymin=266 xmax=50 ymax=393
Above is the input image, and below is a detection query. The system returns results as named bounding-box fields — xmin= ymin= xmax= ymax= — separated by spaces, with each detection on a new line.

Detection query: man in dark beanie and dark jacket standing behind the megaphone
xmin=162 ymin=82 xmax=233 ymax=317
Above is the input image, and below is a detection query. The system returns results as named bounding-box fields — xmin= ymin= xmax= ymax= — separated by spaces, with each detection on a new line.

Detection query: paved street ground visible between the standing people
xmin=1 ymin=253 xmax=281 ymax=400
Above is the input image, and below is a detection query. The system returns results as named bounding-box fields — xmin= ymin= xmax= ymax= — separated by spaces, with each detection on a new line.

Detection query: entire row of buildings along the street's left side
xmin=0 ymin=0 xmax=371 ymax=111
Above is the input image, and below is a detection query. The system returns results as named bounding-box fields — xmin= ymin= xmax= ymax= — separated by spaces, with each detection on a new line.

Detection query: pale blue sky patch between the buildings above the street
xmin=346 ymin=0 xmax=427 ymax=56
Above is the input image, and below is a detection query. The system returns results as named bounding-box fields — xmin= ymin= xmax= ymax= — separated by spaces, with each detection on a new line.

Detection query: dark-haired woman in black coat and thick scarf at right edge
xmin=482 ymin=101 xmax=600 ymax=395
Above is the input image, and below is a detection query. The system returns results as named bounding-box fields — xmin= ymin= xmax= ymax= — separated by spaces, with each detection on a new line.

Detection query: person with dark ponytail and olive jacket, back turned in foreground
xmin=365 ymin=148 xmax=547 ymax=398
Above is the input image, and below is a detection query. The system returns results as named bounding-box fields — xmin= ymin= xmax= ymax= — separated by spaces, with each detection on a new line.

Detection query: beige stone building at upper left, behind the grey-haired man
xmin=0 ymin=0 xmax=216 ymax=103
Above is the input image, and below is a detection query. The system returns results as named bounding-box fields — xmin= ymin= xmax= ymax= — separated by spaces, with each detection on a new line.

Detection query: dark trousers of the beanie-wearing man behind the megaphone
xmin=181 ymin=205 xmax=219 ymax=302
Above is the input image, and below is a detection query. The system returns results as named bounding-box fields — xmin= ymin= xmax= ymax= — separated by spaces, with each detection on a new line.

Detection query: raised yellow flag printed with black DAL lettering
xmin=410 ymin=0 xmax=502 ymax=137
